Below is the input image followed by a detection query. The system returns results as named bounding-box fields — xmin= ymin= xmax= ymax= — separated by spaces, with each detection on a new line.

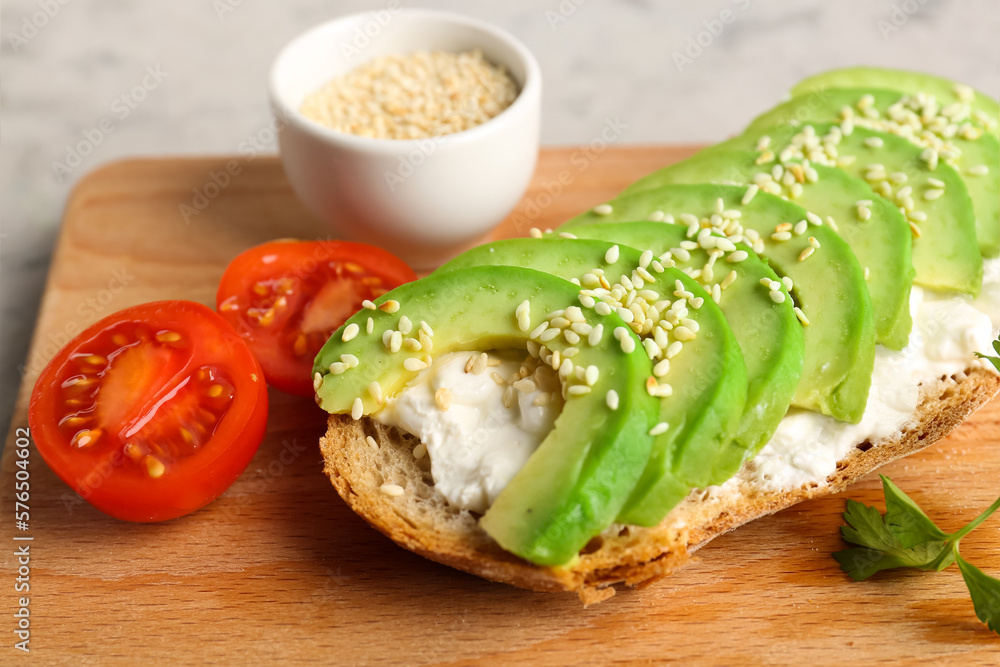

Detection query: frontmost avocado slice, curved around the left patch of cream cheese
xmin=313 ymin=266 xmax=659 ymax=565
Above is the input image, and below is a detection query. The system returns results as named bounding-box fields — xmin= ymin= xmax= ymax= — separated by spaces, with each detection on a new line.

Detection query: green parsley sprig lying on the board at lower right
xmin=833 ymin=474 xmax=1000 ymax=634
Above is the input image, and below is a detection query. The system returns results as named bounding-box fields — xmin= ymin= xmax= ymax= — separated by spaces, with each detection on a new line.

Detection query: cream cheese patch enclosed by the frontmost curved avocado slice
xmin=373 ymin=352 xmax=562 ymax=512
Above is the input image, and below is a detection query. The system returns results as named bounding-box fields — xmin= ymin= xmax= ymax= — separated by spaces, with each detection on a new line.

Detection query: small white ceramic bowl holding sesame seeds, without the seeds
xmin=270 ymin=7 xmax=542 ymax=269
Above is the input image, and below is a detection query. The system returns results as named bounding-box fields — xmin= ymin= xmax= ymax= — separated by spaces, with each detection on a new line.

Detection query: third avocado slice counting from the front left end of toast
xmin=552 ymin=222 xmax=804 ymax=480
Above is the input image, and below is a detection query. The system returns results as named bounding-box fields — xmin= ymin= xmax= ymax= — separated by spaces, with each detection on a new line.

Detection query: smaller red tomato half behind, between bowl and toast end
xmin=216 ymin=240 xmax=417 ymax=396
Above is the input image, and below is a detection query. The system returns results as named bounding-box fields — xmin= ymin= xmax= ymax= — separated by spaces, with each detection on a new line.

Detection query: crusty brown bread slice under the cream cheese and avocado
xmin=320 ymin=367 xmax=1000 ymax=604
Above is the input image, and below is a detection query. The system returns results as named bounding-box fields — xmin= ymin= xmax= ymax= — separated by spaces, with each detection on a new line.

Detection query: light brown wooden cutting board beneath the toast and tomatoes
xmin=0 ymin=146 xmax=1000 ymax=665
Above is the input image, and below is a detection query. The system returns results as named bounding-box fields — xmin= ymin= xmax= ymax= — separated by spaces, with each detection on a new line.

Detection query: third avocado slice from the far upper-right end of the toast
xmin=709 ymin=123 xmax=983 ymax=295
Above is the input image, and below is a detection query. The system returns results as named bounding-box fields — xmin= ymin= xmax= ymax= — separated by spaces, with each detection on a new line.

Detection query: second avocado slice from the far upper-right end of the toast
xmin=748 ymin=88 xmax=1000 ymax=257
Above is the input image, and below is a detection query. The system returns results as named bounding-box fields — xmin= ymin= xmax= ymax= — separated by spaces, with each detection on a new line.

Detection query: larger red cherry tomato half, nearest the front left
xmin=28 ymin=301 xmax=267 ymax=521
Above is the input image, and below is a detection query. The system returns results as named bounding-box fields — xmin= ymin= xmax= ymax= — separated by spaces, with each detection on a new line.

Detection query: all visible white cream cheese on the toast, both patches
xmin=374 ymin=259 xmax=1000 ymax=512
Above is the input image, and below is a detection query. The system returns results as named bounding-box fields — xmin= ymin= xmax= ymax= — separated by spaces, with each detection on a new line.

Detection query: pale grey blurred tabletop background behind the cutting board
xmin=0 ymin=0 xmax=1000 ymax=433
